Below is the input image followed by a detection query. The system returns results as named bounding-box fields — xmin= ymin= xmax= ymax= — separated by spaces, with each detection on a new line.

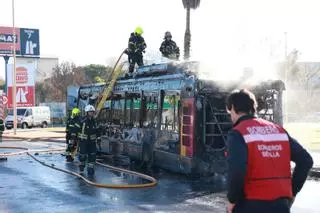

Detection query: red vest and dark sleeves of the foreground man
xmin=227 ymin=116 xmax=313 ymax=203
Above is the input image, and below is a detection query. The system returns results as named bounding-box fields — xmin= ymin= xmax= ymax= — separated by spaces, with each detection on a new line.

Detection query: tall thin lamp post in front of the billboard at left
xmin=12 ymin=0 xmax=17 ymax=135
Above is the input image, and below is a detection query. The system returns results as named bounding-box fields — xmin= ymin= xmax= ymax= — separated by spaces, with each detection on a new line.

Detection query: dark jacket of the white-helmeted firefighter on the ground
xmin=75 ymin=117 xmax=101 ymax=142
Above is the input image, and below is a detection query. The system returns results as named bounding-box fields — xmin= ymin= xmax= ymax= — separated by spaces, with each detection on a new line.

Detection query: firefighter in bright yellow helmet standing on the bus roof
xmin=125 ymin=27 xmax=147 ymax=73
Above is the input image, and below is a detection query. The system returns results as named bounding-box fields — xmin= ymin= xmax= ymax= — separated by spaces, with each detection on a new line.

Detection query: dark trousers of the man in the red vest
xmin=233 ymin=198 xmax=290 ymax=213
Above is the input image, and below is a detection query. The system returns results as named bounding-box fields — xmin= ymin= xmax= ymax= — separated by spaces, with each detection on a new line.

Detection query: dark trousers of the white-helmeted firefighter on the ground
xmin=79 ymin=140 xmax=97 ymax=172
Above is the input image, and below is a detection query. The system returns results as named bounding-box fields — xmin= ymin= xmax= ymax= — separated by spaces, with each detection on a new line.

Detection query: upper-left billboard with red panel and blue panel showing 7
xmin=0 ymin=27 xmax=40 ymax=56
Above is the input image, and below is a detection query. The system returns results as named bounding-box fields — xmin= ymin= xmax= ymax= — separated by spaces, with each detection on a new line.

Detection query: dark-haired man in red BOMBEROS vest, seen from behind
xmin=226 ymin=90 xmax=313 ymax=213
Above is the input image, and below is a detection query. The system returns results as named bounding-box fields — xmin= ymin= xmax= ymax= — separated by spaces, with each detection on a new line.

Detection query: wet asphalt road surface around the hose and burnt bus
xmin=0 ymin=142 xmax=320 ymax=213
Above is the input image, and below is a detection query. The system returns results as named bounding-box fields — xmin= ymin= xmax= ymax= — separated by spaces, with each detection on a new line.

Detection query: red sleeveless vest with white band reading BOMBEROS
xmin=234 ymin=119 xmax=292 ymax=200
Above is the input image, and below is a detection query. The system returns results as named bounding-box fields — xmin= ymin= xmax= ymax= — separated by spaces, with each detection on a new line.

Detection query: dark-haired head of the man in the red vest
xmin=226 ymin=89 xmax=257 ymax=123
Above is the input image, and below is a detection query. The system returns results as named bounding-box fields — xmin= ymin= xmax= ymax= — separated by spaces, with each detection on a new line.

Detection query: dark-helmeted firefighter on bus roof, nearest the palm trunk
xmin=159 ymin=31 xmax=180 ymax=60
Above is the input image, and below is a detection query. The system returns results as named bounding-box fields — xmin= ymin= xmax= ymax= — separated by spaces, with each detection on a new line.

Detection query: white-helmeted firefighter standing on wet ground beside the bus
xmin=75 ymin=105 xmax=101 ymax=175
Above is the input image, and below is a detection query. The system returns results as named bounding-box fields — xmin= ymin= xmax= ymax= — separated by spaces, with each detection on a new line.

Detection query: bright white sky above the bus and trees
xmin=0 ymin=0 xmax=320 ymax=80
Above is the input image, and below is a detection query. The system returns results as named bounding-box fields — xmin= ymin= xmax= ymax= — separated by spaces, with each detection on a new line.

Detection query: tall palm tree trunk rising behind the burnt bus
xmin=182 ymin=0 xmax=200 ymax=60
